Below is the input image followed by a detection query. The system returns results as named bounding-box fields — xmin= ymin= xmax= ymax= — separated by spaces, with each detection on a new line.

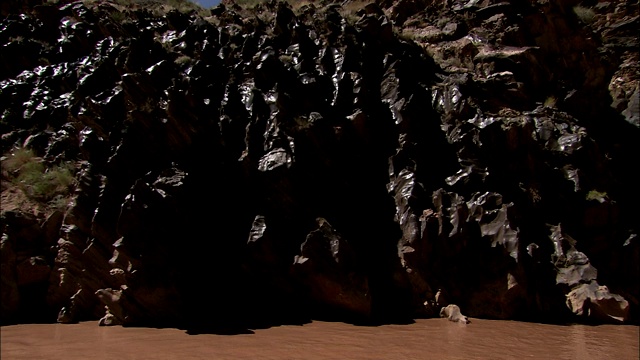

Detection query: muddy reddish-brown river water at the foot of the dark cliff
xmin=0 ymin=319 xmax=640 ymax=360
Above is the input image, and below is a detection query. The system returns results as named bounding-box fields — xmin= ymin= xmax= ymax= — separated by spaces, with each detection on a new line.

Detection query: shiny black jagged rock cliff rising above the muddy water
xmin=0 ymin=0 xmax=640 ymax=327
